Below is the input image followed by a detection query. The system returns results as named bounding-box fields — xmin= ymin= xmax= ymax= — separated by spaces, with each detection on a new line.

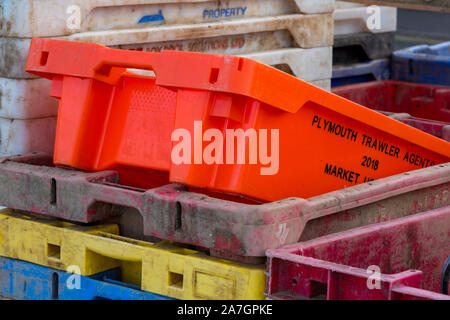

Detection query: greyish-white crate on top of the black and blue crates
xmin=334 ymin=1 xmax=397 ymax=35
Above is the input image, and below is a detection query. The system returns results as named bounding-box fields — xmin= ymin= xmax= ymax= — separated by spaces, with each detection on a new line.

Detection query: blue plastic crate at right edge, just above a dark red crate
xmin=392 ymin=41 xmax=450 ymax=86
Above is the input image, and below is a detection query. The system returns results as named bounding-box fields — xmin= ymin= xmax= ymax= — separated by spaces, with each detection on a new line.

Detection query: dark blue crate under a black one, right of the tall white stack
xmin=331 ymin=59 xmax=390 ymax=87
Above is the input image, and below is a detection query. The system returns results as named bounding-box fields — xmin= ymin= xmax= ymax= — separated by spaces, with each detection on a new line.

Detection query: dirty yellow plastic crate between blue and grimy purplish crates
xmin=0 ymin=209 xmax=266 ymax=300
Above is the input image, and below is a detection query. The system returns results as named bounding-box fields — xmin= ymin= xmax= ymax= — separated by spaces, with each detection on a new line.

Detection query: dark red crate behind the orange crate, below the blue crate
xmin=333 ymin=80 xmax=450 ymax=123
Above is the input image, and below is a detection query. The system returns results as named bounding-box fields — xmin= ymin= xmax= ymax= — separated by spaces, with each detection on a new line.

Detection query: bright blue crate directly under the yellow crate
xmin=0 ymin=257 xmax=173 ymax=300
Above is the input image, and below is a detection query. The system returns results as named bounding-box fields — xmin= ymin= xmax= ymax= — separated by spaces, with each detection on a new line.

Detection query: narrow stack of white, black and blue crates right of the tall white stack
xmin=332 ymin=1 xmax=397 ymax=87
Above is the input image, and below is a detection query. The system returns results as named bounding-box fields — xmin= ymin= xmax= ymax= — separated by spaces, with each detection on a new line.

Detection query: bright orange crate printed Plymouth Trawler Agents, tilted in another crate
xmin=27 ymin=39 xmax=450 ymax=201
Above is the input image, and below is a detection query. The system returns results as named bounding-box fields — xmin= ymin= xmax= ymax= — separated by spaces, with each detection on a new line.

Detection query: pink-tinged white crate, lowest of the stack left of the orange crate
xmin=0 ymin=117 xmax=56 ymax=156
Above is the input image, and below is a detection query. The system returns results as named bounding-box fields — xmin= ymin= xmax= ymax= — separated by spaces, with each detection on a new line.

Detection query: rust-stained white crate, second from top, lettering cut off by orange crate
xmin=0 ymin=13 xmax=333 ymax=80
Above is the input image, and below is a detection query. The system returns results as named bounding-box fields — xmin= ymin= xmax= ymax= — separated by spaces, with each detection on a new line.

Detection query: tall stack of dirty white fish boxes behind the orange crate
xmin=0 ymin=0 xmax=334 ymax=155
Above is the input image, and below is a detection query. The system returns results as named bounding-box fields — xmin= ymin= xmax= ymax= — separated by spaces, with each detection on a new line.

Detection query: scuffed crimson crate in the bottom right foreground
xmin=267 ymin=206 xmax=450 ymax=300
